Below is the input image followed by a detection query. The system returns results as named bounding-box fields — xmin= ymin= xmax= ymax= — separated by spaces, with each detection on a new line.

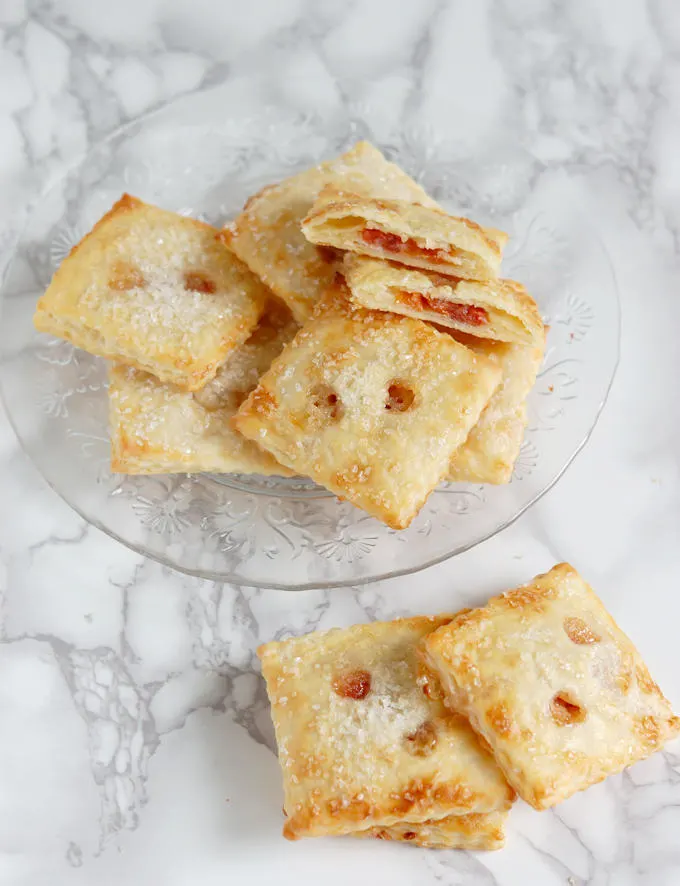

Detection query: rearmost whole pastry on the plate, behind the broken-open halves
xmin=225 ymin=142 xmax=437 ymax=323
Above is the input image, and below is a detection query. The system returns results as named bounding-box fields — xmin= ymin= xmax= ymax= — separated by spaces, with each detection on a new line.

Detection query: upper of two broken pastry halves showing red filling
xmin=302 ymin=188 xmax=507 ymax=280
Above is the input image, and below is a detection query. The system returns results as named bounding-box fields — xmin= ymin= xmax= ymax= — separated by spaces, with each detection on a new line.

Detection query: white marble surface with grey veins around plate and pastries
xmin=0 ymin=0 xmax=680 ymax=886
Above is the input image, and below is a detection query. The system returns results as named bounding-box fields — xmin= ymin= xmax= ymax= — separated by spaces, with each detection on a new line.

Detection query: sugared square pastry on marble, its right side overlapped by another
xmin=258 ymin=616 xmax=514 ymax=839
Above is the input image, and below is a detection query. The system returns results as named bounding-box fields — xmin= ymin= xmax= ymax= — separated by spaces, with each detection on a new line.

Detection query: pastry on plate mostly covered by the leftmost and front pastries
xmin=109 ymin=304 xmax=297 ymax=477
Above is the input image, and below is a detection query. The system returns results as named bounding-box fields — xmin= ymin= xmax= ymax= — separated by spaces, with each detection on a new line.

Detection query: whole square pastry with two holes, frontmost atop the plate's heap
xmin=234 ymin=287 xmax=502 ymax=529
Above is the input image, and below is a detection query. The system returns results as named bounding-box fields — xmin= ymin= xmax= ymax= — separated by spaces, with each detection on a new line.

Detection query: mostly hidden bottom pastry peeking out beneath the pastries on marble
xmin=358 ymin=812 xmax=508 ymax=850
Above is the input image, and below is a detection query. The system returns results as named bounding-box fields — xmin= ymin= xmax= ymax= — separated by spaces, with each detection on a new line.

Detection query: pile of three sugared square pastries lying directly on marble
xmin=258 ymin=563 xmax=680 ymax=849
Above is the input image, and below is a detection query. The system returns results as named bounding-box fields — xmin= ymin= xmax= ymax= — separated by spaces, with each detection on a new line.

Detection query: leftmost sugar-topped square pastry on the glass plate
xmin=34 ymin=194 xmax=268 ymax=391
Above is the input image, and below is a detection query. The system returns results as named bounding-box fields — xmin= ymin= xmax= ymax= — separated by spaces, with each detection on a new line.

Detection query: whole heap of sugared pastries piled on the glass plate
xmin=35 ymin=143 xmax=544 ymax=529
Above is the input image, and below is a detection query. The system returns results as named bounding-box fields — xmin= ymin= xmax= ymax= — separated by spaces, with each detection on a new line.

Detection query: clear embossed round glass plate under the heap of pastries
xmin=0 ymin=93 xmax=619 ymax=589
